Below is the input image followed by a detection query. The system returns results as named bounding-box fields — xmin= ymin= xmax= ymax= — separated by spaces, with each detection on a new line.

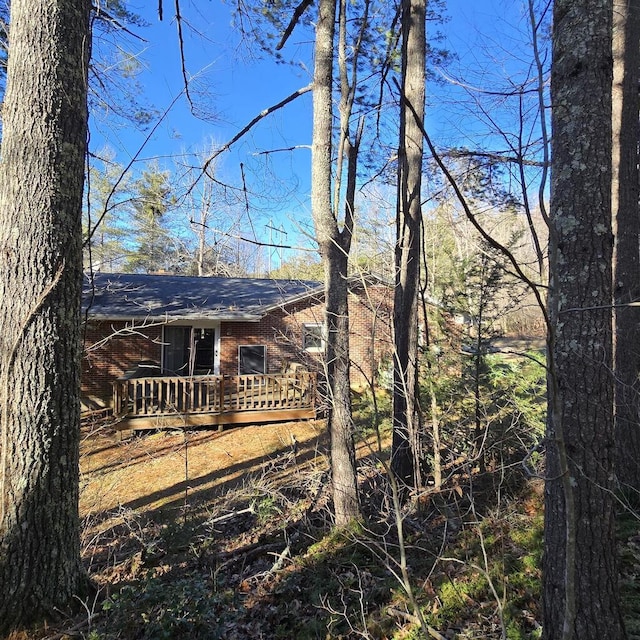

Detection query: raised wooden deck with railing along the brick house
xmin=113 ymin=372 xmax=317 ymax=430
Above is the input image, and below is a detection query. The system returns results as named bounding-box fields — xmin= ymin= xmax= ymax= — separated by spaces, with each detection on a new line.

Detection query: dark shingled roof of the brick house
xmin=83 ymin=273 xmax=324 ymax=322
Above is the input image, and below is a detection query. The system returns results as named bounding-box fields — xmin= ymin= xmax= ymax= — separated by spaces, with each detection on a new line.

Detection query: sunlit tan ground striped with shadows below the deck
xmin=80 ymin=421 xmax=326 ymax=519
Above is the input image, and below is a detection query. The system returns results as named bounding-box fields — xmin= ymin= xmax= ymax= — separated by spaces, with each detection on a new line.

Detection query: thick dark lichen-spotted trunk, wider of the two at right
xmin=543 ymin=0 xmax=625 ymax=640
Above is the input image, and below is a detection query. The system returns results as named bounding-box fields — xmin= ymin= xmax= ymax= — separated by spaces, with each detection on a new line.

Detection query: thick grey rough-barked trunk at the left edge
xmin=0 ymin=0 xmax=90 ymax=635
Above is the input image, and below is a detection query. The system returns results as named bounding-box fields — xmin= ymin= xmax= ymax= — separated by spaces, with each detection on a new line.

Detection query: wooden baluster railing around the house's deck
xmin=113 ymin=371 xmax=317 ymax=418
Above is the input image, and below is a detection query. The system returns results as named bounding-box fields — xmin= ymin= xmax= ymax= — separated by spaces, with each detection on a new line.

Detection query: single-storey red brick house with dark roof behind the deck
xmin=82 ymin=273 xmax=393 ymax=407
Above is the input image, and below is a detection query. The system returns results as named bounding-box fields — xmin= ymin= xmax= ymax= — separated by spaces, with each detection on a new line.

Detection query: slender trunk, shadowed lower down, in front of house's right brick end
xmin=391 ymin=0 xmax=426 ymax=486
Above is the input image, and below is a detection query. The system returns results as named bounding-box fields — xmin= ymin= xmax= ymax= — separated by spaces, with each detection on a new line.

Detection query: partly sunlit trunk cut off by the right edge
xmin=612 ymin=0 xmax=640 ymax=491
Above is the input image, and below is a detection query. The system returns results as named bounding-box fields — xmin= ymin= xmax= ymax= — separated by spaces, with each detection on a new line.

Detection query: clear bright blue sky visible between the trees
xmin=92 ymin=0 xmax=548 ymax=260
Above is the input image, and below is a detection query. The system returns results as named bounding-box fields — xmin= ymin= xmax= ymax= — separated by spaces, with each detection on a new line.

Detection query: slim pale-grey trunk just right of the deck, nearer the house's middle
xmin=311 ymin=0 xmax=360 ymax=526
